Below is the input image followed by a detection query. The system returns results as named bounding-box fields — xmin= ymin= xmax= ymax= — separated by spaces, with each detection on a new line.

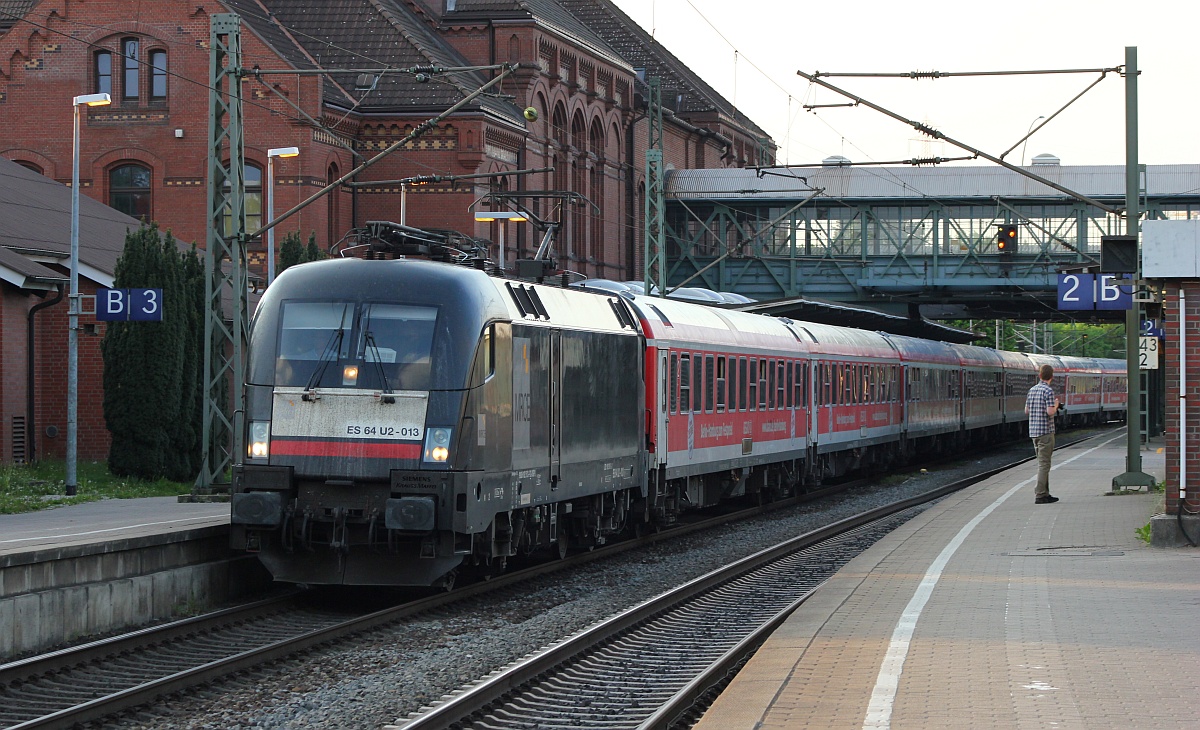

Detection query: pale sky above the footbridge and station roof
xmin=613 ymin=0 xmax=1200 ymax=164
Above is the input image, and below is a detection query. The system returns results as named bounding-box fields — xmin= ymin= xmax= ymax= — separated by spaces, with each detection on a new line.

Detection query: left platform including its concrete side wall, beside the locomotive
xmin=0 ymin=497 xmax=253 ymax=664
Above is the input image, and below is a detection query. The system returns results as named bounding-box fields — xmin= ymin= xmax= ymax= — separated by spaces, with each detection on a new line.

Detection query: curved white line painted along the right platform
xmin=863 ymin=436 xmax=1123 ymax=730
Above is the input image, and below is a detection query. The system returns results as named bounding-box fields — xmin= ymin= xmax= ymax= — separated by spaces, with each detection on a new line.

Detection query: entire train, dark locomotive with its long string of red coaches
xmin=233 ymin=258 xmax=1126 ymax=586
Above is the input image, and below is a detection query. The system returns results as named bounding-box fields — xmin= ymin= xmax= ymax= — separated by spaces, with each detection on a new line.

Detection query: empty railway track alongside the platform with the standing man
xmin=386 ymin=432 xmax=1099 ymax=730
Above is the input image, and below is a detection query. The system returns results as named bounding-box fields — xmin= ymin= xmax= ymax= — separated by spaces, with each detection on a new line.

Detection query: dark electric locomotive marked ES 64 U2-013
xmin=232 ymin=258 xmax=646 ymax=586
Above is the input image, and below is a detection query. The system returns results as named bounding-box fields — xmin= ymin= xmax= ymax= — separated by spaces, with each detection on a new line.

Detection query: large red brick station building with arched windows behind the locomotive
xmin=0 ymin=0 xmax=775 ymax=462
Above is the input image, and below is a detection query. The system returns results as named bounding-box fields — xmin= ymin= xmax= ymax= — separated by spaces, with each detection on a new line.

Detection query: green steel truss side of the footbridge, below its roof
xmin=666 ymin=196 xmax=1200 ymax=310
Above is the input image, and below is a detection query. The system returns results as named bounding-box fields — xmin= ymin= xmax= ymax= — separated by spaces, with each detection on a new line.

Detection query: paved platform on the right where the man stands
xmin=695 ymin=430 xmax=1200 ymax=730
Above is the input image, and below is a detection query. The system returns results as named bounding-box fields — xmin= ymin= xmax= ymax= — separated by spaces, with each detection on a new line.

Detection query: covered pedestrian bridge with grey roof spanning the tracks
xmin=665 ymin=160 xmax=1200 ymax=321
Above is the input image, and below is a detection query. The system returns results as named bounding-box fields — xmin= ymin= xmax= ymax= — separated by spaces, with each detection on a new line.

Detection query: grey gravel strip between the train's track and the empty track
xmin=104 ymin=439 xmax=1070 ymax=730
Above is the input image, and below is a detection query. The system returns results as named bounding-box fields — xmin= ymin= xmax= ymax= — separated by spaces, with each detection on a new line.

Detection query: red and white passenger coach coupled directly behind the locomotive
xmin=634 ymin=297 xmax=809 ymax=505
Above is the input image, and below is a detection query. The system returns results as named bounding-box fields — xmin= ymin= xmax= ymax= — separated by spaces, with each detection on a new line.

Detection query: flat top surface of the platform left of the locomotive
xmin=0 ymin=497 xmax=229 ymax=556
